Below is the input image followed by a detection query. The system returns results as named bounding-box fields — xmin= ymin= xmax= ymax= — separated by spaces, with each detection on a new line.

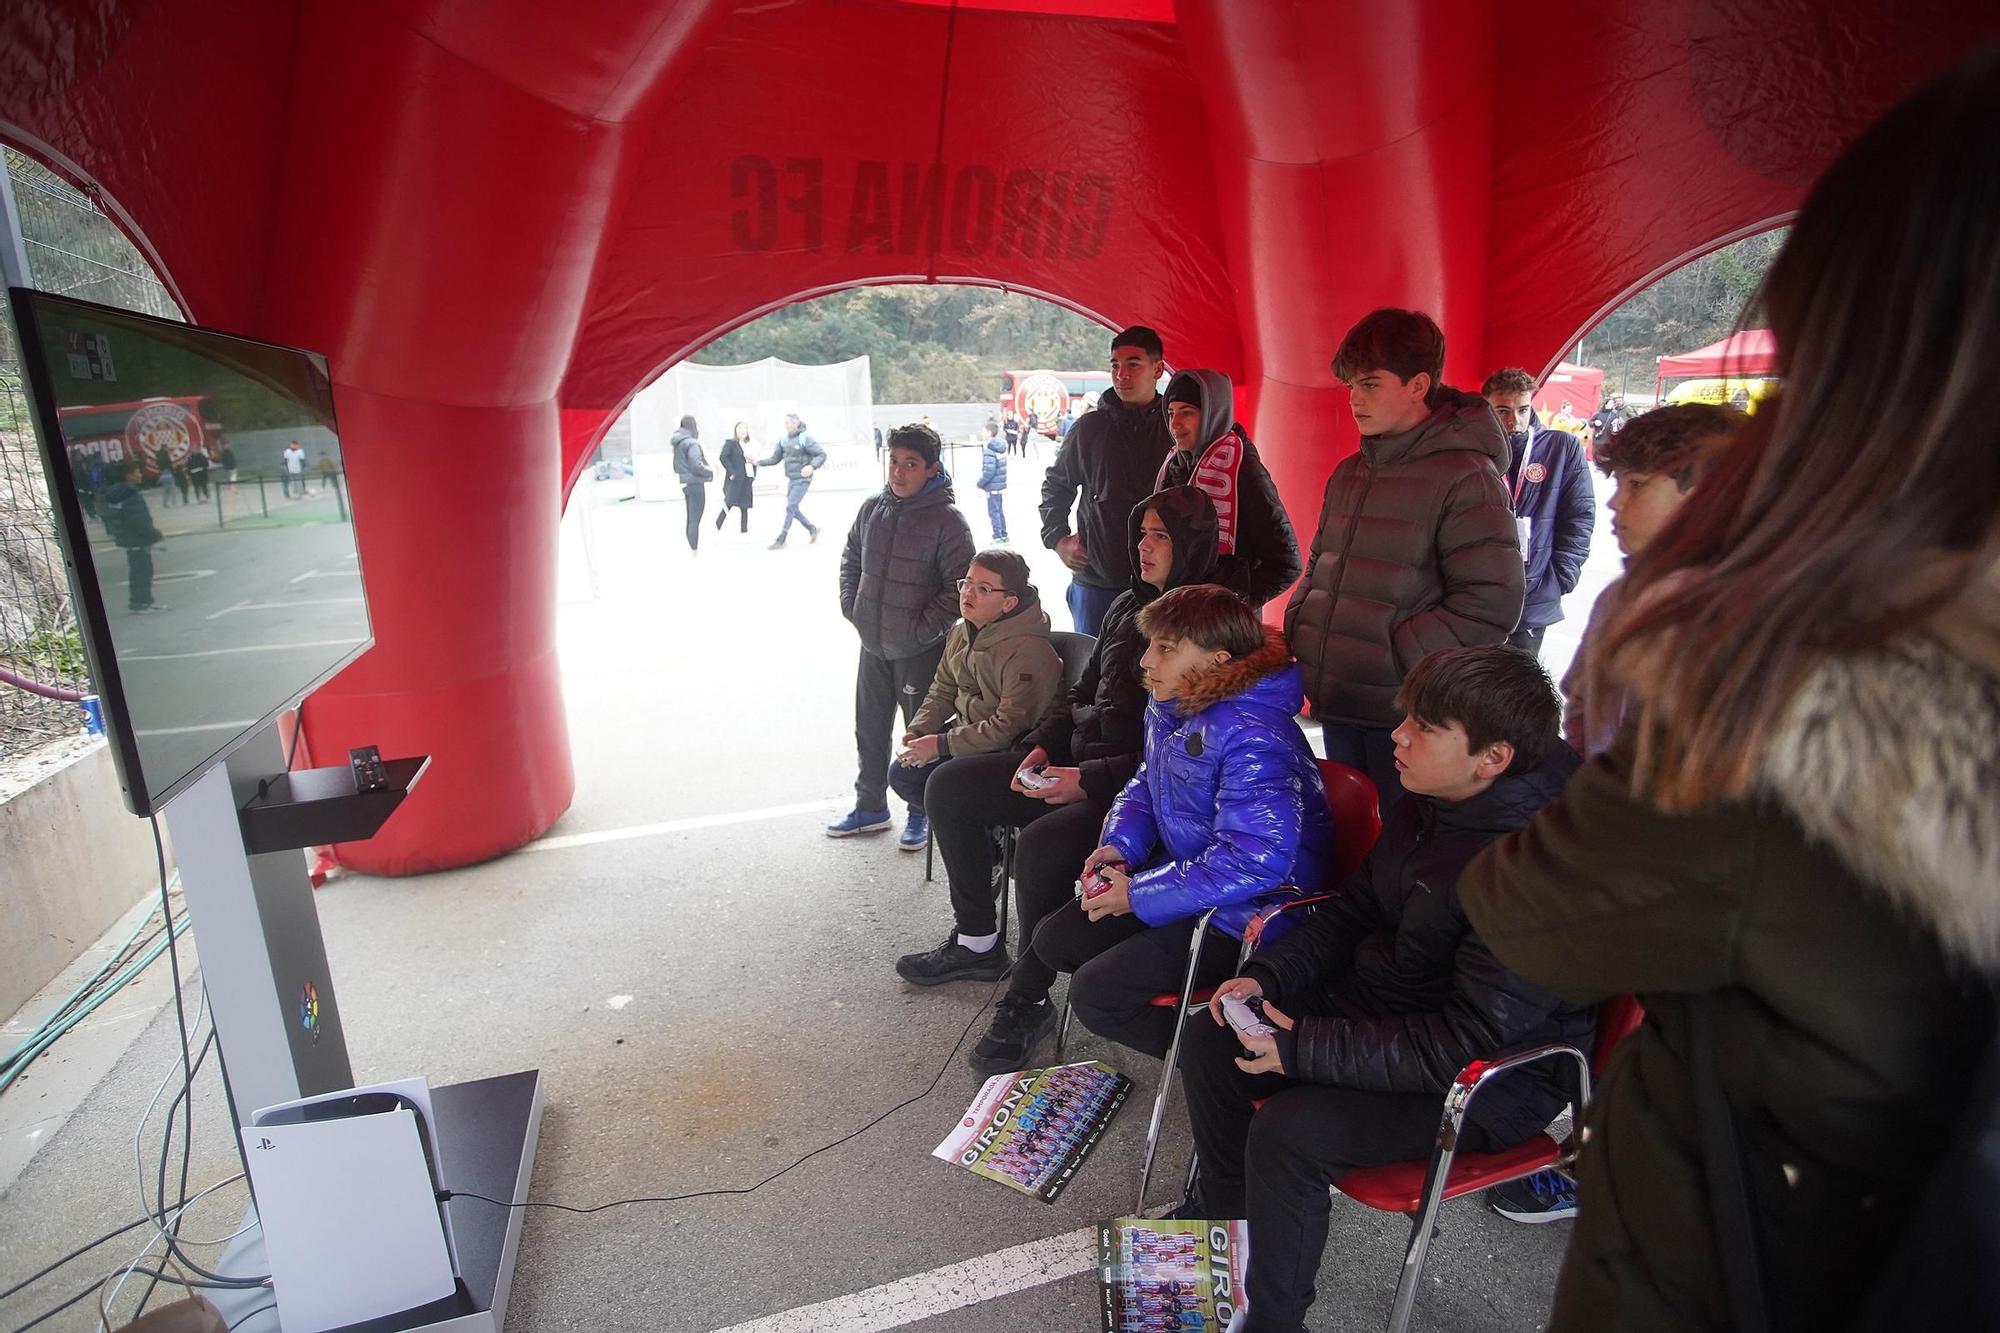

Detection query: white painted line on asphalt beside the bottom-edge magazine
xmin=716 ymin=1227 xmax=1098 ymax=1333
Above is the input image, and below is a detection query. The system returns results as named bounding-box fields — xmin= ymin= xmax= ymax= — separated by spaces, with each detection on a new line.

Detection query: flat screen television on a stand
xmin=8 ymin=288 xmax=374 ymax=815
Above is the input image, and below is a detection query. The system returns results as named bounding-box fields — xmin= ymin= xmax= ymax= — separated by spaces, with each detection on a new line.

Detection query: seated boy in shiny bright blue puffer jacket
xmin=1034 ymin=582 xmax=1332 ymax=1057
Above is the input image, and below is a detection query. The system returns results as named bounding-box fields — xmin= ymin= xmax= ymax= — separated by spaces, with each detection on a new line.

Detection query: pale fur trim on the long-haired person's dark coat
xmin=1758 ymin=560 xmax=2000 ymax=973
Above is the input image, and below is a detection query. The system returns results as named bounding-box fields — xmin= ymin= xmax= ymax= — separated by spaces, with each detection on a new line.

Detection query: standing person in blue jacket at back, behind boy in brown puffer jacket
xmin=1480 ymin=366 xmax=1598 ymax=656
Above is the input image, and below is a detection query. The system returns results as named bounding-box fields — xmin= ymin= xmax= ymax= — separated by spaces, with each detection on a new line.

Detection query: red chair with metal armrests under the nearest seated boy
xmin=1334 ymin=995 xmax=1646 ymax=1333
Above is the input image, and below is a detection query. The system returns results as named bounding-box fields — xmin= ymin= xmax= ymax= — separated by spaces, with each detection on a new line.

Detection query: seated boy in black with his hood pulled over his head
xmin=896 ymin=486 xmax=1216 ymax=1073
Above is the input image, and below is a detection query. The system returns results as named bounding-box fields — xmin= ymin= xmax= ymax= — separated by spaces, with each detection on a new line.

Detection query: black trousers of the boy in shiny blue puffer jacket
xmin=1034 ymin=901 xmax=1242 ymax=1059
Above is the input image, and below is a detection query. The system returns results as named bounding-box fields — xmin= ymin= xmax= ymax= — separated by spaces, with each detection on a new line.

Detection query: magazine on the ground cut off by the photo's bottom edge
xmin=1098 ymin=1217 xmax=1250 ymax=1333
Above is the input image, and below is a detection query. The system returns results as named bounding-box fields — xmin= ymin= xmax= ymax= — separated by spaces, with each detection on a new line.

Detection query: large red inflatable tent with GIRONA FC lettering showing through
xmin=0 ymin=0 xmax=2000 ymax=873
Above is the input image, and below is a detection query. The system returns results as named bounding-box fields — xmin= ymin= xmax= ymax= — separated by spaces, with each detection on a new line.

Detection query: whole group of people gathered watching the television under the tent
xmin=828 ymin=56 xmax=2000 ymax=1333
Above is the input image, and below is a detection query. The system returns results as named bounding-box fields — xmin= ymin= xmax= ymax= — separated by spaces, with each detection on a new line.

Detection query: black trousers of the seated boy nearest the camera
xmin=1180 ymin=1005 xmax=1500 ymax=1333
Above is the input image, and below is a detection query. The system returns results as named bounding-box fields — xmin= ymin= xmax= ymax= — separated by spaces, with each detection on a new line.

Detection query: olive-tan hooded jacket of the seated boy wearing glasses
xmin=910 ymin=584 xmax=1062 ymax=759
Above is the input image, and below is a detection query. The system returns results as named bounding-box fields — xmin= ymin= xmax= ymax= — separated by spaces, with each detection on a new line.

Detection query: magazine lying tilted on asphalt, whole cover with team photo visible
xmin=930 ymin=1061 xmax=1132 ymax=1203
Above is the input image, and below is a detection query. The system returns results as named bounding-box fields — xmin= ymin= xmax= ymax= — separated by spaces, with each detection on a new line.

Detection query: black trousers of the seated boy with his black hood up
xmin=924 ymin=751 xmax=1110 ymax=956
